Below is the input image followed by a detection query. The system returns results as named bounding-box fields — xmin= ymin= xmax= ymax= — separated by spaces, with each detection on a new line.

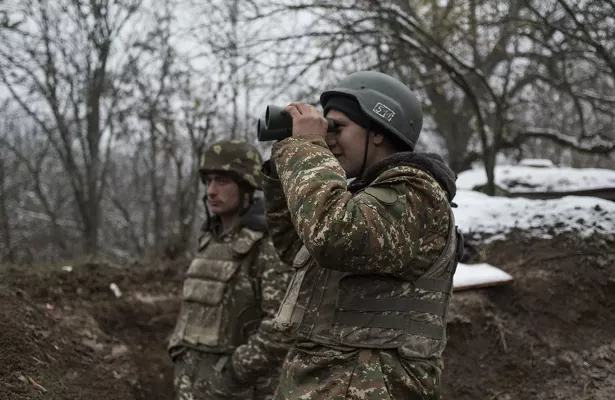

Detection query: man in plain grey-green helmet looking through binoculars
xmin=263 ymin=71 xmax=462 ymax=400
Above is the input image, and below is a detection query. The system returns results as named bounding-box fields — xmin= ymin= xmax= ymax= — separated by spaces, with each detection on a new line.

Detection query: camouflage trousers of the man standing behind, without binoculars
xmin=173 ymin=348 xmax=278 ymax=400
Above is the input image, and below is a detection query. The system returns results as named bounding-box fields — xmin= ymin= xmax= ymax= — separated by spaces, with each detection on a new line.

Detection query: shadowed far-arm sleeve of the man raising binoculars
xmin=263 ymin=160 xmax=303 ymax=265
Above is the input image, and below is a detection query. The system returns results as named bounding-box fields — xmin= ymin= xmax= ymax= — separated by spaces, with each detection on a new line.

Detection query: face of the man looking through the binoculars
xmin=326 ymin=110 xmax=368 ymax=178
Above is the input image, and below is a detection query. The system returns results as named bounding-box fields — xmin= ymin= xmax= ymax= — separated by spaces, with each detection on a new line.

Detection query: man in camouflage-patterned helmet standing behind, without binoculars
xmin=168 ymin=140 xmax=291 ymax=400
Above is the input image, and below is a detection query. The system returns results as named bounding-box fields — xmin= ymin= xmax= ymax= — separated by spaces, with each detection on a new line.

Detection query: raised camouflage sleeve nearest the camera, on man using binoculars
xmin=272 ymin=136 xmax=450 ymax=279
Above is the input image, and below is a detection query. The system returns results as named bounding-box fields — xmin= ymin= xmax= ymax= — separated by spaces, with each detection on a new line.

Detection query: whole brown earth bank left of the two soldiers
xmin=0 ymin=262 xmax=185 ymax=400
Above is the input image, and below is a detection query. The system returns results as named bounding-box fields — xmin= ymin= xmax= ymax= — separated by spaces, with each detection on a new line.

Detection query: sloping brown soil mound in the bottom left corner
xmin=0 ymin=285 xmax=135 ymax=400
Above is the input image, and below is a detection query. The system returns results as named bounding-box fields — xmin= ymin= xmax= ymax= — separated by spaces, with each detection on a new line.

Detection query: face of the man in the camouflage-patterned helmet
xmin=203 ymin=173 xmax=239 ymax=216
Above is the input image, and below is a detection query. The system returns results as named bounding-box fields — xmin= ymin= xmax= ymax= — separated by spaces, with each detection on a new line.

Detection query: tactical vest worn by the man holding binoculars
xmin=275 ymin=212 xmax=463 ymax=358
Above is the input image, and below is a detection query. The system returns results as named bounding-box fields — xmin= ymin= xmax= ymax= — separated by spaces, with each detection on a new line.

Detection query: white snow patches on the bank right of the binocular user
xmin=453 ymin=163 xmax=615 ymax=291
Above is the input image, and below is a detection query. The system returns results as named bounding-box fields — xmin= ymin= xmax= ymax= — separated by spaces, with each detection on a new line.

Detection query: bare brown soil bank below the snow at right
xmin=444 ymin=233 xmax=615 ymax=400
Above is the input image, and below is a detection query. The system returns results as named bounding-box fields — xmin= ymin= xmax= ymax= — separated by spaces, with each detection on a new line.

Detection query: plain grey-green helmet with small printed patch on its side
xmin=320 ymin=71 xmax=423 ymax=149
